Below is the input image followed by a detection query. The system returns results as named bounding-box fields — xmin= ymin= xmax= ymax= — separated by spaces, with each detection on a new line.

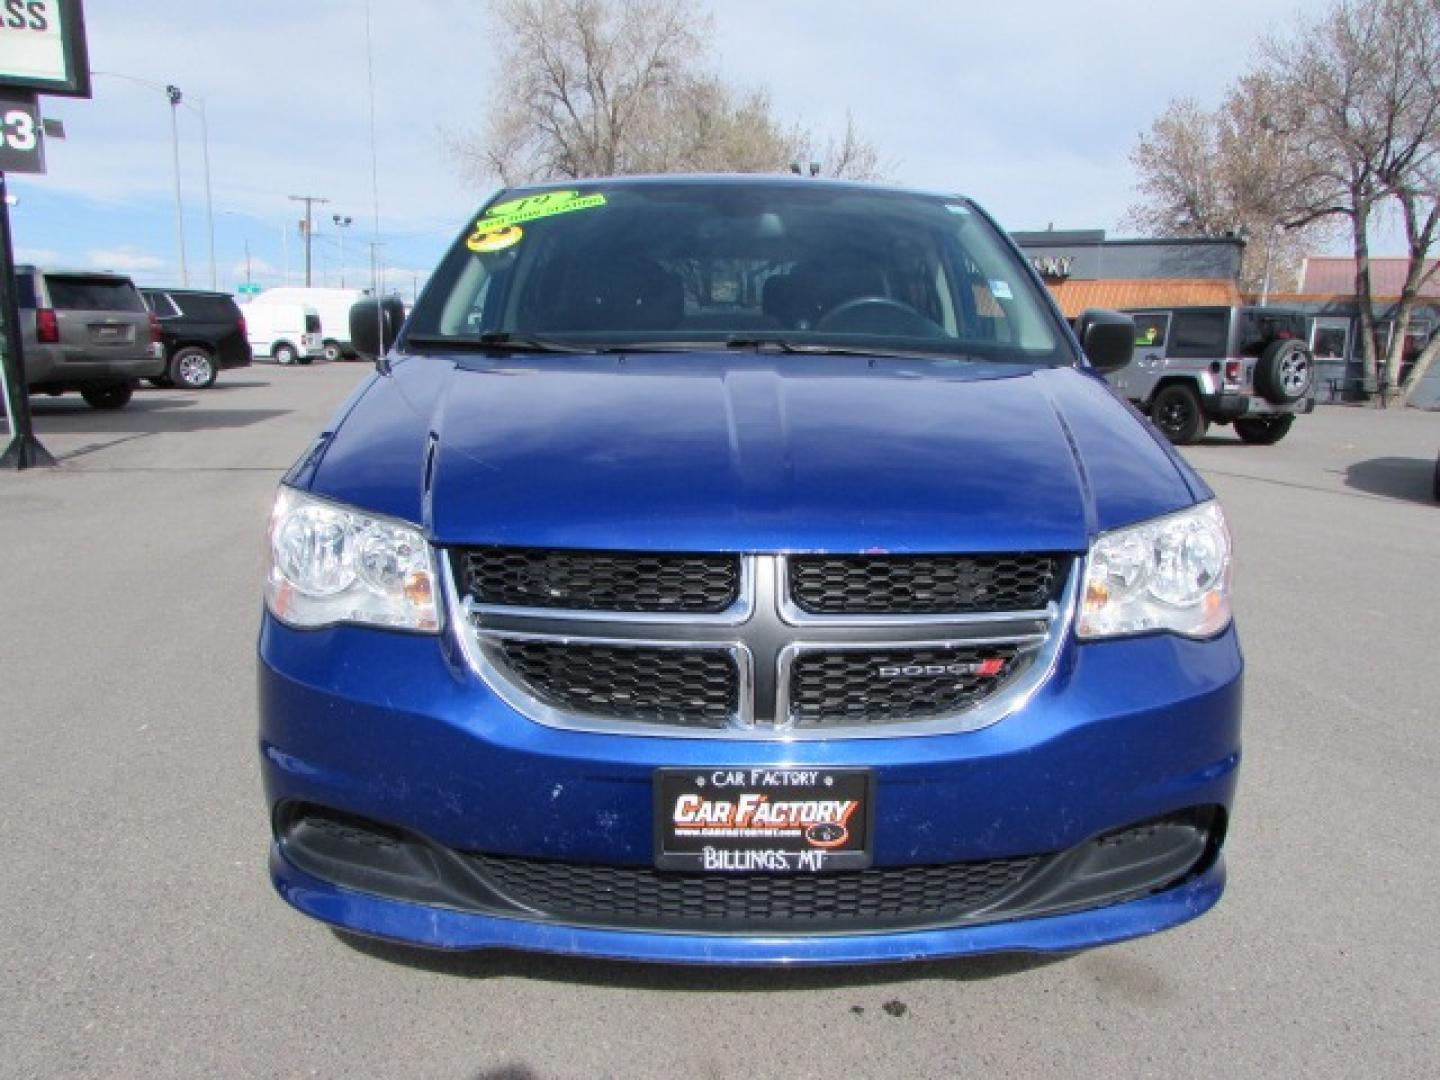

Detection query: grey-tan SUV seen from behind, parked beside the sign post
xmin=14 ymin=266 xmax=166 ymax=409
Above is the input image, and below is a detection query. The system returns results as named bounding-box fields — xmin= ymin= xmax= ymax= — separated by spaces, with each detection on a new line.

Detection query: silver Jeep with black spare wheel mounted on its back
xmin=1106 ymin=307 xmax=1316 ymax=446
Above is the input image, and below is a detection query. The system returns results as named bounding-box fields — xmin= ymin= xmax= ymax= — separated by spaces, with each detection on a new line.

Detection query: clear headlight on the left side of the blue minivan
xmin=265 ymin=487 xmax=439 ymax=632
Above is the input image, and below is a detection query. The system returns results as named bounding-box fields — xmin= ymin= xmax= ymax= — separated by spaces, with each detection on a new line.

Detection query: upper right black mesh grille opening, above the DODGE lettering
xmin=789 ymin=554 xmax=1064 ymax=615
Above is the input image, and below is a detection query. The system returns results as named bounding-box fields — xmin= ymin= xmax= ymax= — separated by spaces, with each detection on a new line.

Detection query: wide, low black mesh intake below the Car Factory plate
xmin=467 ymin=855 xmax=1041 ymax=930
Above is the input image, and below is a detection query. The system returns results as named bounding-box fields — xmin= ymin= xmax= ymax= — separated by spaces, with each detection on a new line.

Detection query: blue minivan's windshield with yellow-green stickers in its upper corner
xmin=409 ymin=180 xmax=1073 ymax=364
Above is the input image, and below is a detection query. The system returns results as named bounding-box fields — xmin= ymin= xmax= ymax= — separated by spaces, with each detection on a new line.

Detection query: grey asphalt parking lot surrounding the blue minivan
xmin=0 ymin=364 xmax=1440 ymax=1080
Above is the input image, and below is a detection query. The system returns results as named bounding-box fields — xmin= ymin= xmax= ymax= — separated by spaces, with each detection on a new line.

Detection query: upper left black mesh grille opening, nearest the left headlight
xmin=455 ymin=547 xmax=740 ymax=615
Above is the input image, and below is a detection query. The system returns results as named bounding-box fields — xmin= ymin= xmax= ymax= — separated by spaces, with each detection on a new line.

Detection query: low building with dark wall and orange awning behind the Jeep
xmin=1012 ymin=229 xmax=1440 ymax=408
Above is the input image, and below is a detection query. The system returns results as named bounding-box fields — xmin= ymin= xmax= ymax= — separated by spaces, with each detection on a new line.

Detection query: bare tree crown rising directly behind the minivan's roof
xmin=446 ymin=0 xmax=880 ymax=184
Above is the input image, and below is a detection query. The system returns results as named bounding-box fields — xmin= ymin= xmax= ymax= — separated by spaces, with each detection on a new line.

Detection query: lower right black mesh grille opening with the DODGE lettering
xmin=789 ymin=645 xmax=1028 ymax=727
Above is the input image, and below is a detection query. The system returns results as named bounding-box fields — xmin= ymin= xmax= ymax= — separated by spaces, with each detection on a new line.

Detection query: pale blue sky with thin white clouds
xmin=12 ymin=0 xmax=1342 ymax=295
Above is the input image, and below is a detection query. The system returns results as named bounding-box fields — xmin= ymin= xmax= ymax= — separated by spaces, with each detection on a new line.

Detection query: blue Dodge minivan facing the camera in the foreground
xmin=259 ymin=177 xmax=1243 ymax=963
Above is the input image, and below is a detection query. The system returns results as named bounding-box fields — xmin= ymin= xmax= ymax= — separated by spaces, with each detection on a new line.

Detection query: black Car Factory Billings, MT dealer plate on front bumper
xmin=655 ymin=769 xmax=874 ymax=874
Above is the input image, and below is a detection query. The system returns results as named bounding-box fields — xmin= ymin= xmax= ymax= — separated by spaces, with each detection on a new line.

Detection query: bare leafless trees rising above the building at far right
xmin=1126 ymin=0 xmax=1440 ymax=387
